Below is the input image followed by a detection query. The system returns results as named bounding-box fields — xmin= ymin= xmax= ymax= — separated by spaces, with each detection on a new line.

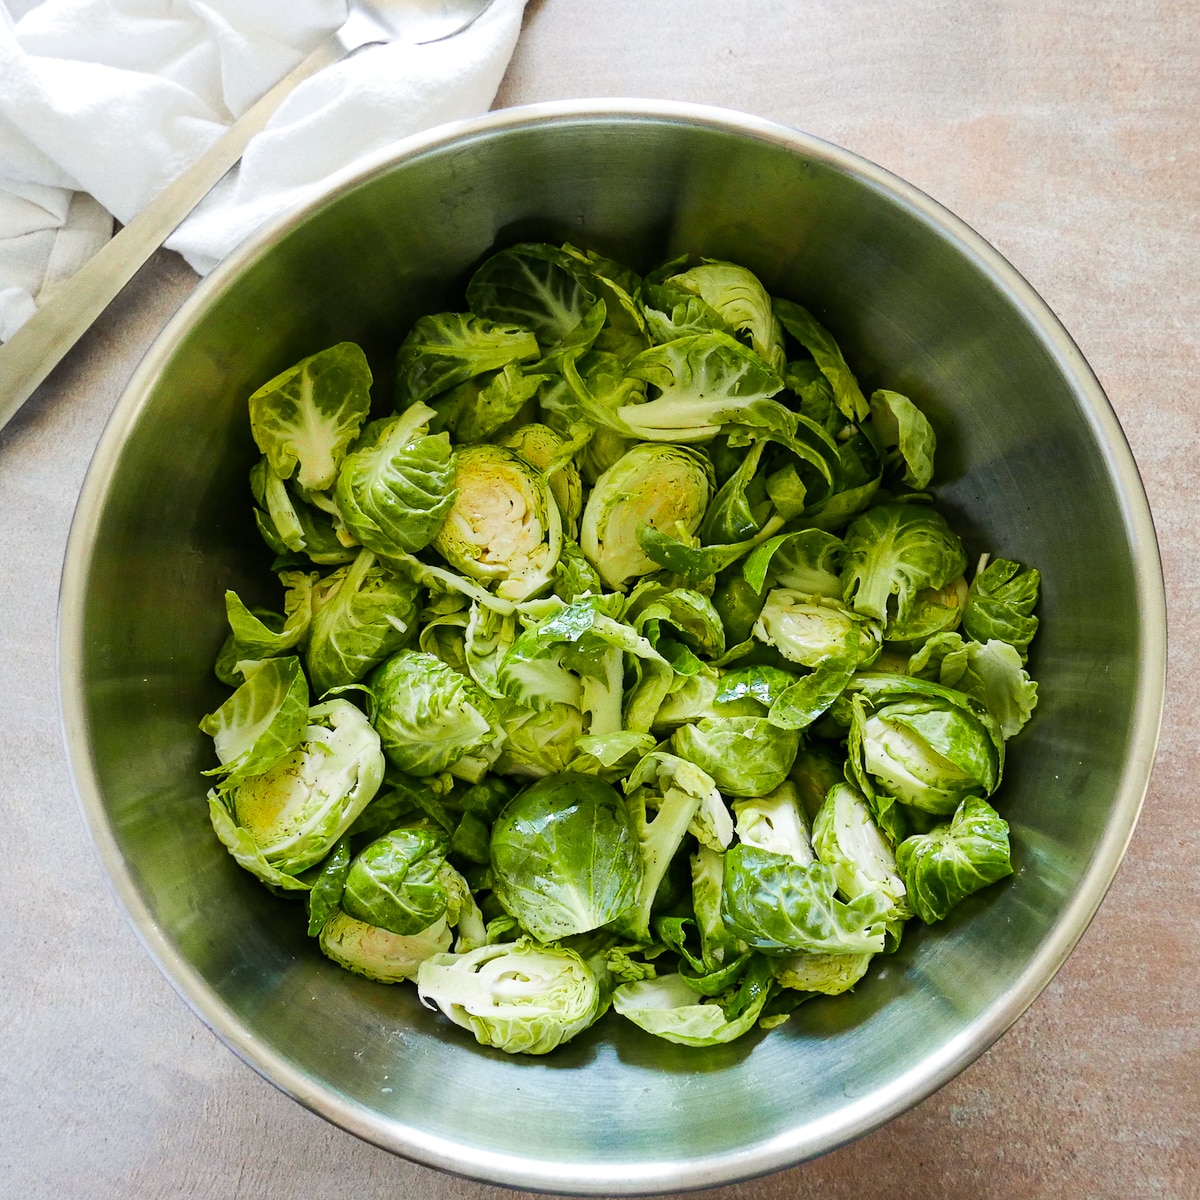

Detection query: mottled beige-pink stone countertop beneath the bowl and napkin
xmin=0 ymin=0 xmax=1200 ymax=1200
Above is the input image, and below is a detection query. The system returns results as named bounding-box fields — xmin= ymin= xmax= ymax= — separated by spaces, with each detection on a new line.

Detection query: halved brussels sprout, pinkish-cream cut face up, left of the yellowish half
xmin=433 ymin=444 xmax=563 ymax=600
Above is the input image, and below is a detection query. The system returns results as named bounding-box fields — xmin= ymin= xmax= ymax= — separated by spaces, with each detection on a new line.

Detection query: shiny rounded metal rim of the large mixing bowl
xmin=58 ymin=97 xmax=1166 ymax=1195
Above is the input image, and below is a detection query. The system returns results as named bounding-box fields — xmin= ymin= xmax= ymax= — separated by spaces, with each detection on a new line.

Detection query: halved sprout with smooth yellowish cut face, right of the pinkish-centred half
xmin=580 ymin=443 xmax=713 ymax=589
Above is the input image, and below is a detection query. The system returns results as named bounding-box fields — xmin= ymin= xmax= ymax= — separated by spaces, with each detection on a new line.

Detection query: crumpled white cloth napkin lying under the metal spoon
xmin=0 ymin=0 xmax=526 ymax=341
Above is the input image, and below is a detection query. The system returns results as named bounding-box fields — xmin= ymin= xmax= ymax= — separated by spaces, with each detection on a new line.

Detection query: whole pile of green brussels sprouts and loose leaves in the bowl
xmin=202 ymin=244 xmax=1039 ymax=1054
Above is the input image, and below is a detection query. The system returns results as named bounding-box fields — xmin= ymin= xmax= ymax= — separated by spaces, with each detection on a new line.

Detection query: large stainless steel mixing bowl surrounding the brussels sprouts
xmin=60 ymin=102 xmax=1165 ymax=1195
